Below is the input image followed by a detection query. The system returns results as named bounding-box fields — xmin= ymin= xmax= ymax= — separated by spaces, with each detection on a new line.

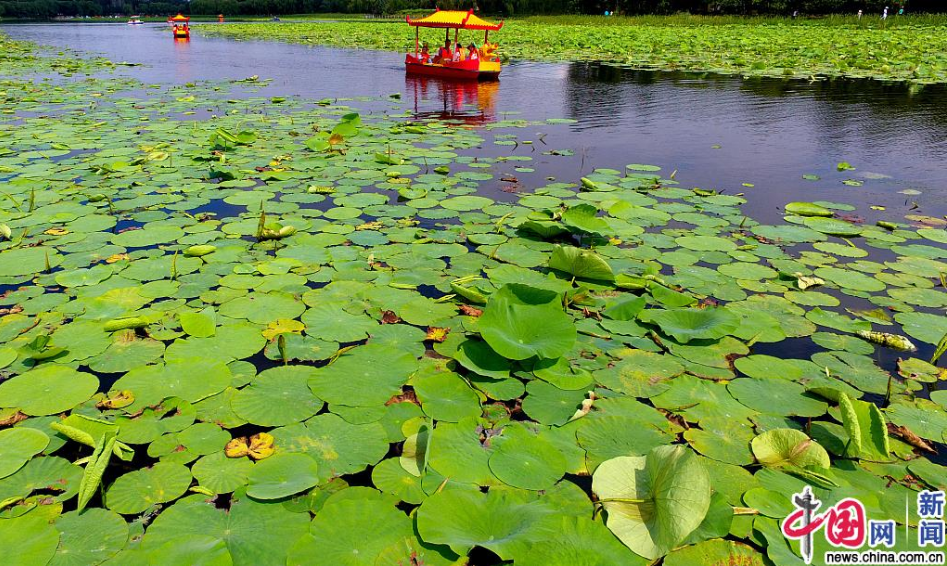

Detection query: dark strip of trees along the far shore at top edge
xmin=0 ymin=0 xmax=932 ymax=19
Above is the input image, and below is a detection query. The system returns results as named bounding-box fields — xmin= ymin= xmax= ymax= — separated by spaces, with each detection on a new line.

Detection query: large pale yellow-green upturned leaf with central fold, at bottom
xmin=592 ymin=446 xmax=711 ymax=559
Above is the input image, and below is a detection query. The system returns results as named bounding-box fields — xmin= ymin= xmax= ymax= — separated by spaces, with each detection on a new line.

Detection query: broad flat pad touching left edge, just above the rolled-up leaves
xmin=0 ymin=364 xmax=99 ymax=415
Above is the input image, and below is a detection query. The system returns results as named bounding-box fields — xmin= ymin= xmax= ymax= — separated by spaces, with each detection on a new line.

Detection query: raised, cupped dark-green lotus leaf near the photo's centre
xmin=479 ymin=284 xmax=576 ymax=360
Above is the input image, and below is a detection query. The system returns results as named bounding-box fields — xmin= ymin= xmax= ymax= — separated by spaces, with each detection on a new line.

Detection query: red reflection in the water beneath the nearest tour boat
xmin=405 ymin=75 xmax=500 ymax=126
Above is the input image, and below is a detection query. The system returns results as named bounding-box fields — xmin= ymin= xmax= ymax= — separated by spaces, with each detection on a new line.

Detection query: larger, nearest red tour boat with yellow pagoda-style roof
xmin=404 ymin=10 xmax=503 ymax=80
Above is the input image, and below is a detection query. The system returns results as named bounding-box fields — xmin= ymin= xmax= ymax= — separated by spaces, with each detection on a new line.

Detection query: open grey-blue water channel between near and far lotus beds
xmin=0 ymin=23 xmax=947 ymax=225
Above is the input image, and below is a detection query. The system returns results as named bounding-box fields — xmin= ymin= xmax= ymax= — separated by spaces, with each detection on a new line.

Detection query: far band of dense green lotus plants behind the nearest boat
xmin=199 ymin=15 xmax=947 ymax=84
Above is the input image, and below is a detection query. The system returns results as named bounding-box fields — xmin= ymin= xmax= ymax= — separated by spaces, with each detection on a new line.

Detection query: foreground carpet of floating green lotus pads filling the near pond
xmin=0 ymin=27 xmax=947 ymax=566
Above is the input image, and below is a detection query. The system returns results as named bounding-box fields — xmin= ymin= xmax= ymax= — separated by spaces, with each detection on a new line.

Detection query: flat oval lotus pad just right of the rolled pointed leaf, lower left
xmin=105 ymin=462 xmax=191 ymax=515
